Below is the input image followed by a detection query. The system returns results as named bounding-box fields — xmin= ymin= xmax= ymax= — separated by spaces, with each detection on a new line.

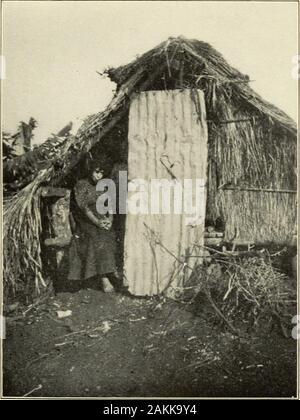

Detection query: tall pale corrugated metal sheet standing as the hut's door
xmin=124 ymin=90 xmax=207 ymax=296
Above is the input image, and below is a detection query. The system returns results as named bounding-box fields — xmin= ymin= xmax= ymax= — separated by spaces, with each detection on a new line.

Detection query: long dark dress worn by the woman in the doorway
xmin=68 ymin=179 xmax=116 ymax=280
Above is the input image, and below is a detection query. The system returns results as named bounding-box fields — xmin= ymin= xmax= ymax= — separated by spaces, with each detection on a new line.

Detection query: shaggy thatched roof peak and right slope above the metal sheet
xmin=107 ymin=38 xmax=296 ymax=133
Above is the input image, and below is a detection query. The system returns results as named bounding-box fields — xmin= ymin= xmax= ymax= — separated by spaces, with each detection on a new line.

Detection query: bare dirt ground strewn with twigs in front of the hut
xmin=4 ymin=282 xmax=296 ymax=397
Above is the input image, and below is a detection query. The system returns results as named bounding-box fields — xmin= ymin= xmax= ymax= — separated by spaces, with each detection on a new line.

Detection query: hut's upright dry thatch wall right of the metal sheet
xmin=203 ymin=82 xmax=297 ymax=243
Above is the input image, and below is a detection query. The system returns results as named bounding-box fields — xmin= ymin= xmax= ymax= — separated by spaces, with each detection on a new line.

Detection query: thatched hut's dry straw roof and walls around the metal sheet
xmin=4 ymin=38 xmax=297 ymax=298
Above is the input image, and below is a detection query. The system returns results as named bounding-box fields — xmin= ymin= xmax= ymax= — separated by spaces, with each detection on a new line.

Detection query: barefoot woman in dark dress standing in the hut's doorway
xmin=68 ymin=161 xmax=118 ymax=293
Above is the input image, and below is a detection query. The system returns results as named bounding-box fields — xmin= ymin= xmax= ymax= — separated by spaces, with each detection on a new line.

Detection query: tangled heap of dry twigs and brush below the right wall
xmin=195 ymin=250 xmax=297 ymax=336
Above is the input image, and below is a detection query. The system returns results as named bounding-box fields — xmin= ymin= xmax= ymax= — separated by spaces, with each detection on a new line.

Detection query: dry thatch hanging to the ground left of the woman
xmin=3 ymin=169 xmax=52 ymax=300
